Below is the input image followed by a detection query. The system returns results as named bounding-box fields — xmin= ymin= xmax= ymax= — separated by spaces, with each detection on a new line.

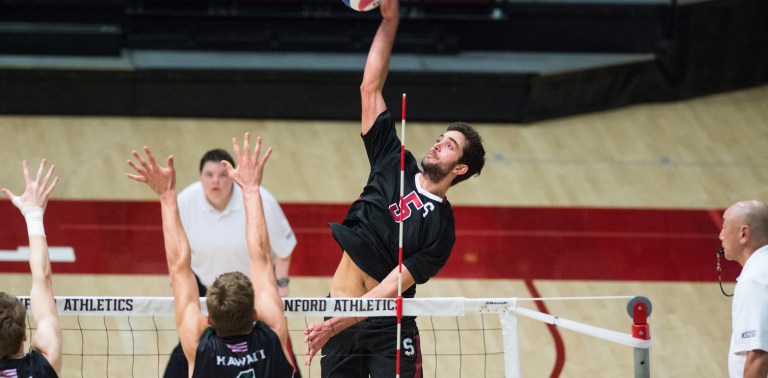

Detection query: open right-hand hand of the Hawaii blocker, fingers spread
xmin=221 ymin=133 xmax=272 ymax=192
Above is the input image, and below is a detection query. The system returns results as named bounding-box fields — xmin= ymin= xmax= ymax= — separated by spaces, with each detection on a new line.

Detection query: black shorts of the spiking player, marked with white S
xmin=320 ymin=317 xmax=422 ymax=378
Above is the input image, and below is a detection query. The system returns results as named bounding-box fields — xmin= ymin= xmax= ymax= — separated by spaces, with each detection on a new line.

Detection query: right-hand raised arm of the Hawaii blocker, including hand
xmin=222 ymin=133 xmax=291 ymax=361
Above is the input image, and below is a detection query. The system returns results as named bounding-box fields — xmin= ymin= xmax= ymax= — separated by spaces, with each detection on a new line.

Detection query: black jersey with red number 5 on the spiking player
xmin=330 ymin=110 xmax=456 ymax=298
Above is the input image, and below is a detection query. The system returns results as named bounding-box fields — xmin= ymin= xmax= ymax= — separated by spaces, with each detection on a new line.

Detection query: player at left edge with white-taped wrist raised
xmin=0 ymin=159 xmax=62 ymax=378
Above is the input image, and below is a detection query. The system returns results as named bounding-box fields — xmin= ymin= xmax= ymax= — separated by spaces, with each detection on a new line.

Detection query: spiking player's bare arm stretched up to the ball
xmin=360 ymin=0 xmax=400 ymax=135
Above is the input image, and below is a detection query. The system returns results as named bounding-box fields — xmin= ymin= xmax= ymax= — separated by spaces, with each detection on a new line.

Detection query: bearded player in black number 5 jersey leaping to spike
xmin=305 ymin=0 xmax=485 ymax=377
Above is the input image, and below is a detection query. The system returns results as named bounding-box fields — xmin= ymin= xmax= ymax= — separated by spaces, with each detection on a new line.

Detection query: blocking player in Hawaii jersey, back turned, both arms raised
xmin=127 ymin=133 xmax=295 ymax=378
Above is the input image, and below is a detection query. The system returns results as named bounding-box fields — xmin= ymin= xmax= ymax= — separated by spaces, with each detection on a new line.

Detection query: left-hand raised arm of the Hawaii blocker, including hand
xmin=126 ymin=147 xmax=207 ymax=372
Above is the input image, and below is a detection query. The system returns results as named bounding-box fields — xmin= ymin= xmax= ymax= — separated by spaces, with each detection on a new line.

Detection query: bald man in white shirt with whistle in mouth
xmin=720 ymin=200 xmax=768 ymax=378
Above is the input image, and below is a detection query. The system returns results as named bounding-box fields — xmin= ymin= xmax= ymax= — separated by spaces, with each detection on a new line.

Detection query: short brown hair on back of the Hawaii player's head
xmin=206 ymin=272 xmax=254 ymax=336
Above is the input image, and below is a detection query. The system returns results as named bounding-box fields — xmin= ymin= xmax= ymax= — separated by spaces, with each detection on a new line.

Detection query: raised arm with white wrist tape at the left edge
xmin=2 ymin=159 xmax=62 ymax=374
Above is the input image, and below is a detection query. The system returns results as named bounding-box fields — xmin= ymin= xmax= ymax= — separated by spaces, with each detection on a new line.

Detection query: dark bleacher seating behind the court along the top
xmin=0 ymin=0 xmax=768 ymax=122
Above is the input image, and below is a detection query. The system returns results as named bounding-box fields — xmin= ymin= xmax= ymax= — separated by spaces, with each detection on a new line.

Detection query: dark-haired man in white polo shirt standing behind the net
xmin=165 ymin=149 xmax=296 ymax=377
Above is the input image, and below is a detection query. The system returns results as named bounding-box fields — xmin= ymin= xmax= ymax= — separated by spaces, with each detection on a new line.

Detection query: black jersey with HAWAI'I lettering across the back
xmin=192 ymin=322 xmax=293 ymax=378
